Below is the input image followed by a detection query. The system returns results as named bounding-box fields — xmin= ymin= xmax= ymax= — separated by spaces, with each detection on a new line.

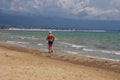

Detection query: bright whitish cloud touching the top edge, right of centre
xmin=59 ymin=0 xmax=89 ymax=15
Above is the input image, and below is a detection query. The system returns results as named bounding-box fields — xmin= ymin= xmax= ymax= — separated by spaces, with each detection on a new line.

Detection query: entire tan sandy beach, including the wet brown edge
xmin=0 ymin=43 xmax=120 ymax=80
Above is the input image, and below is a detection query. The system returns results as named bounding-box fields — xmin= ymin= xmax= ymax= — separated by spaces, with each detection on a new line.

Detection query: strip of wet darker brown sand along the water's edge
xmin=0 ymin=43 xmax=120 ymax=73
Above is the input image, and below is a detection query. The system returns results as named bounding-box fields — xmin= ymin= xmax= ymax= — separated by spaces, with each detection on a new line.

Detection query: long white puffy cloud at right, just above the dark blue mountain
xmin=84 ymin=7 xmax=120 ymax=20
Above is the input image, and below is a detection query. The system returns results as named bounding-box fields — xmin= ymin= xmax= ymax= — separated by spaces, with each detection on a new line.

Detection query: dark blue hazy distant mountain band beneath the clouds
xmin=0 ymin=13 xmax=120 ymax=30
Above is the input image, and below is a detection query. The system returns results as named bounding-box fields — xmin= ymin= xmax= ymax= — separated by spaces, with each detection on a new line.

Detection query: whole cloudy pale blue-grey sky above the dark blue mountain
xmin=0 ymin=0 xmax=120 ymax=20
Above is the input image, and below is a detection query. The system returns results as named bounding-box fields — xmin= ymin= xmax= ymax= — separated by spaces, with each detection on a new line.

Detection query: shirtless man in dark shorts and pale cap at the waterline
xmin=46 ymin=31 xmax=55 ymax=53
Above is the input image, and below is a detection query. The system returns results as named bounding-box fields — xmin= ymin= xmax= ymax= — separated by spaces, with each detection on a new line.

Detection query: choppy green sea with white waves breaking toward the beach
xmin=0 ymin=30 xmax=120 ymax=61
